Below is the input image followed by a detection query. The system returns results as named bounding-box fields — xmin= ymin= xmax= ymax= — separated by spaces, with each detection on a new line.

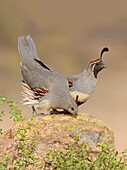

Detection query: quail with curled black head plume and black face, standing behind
xmin=67 ymin=47 xmax=109 ymax=106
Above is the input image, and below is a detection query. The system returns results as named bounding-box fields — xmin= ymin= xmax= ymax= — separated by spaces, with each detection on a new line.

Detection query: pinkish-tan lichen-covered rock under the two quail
xmin=0 ymin=113 xmax=114 ymax=157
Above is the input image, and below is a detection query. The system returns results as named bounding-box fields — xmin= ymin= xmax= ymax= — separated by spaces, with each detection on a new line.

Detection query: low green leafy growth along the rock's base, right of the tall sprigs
xmin=45 ymin=141 xmax=127 ymax=170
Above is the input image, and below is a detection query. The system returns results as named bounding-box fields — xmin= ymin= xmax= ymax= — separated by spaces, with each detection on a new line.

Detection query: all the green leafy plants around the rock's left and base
xmin=0 ymin=97 xmax=127 ymax=170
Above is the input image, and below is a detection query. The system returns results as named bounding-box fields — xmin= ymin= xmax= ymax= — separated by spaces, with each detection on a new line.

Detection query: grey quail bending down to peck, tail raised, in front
xmin=18 ymin=35 xmax=78 ymax=117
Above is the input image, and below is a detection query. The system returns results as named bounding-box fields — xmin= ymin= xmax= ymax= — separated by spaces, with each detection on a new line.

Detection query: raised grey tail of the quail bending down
xmin=18 ymin=35 xmax=39 ymax=61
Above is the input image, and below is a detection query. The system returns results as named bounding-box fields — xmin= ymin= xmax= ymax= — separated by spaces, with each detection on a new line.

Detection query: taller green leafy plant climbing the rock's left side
xmin=0 ymin=97 xmax=41 ymax=170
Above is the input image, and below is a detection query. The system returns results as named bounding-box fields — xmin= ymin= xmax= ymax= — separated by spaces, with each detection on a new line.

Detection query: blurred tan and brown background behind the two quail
xmin=0 ymin=0 xmax=127 ymax=151
